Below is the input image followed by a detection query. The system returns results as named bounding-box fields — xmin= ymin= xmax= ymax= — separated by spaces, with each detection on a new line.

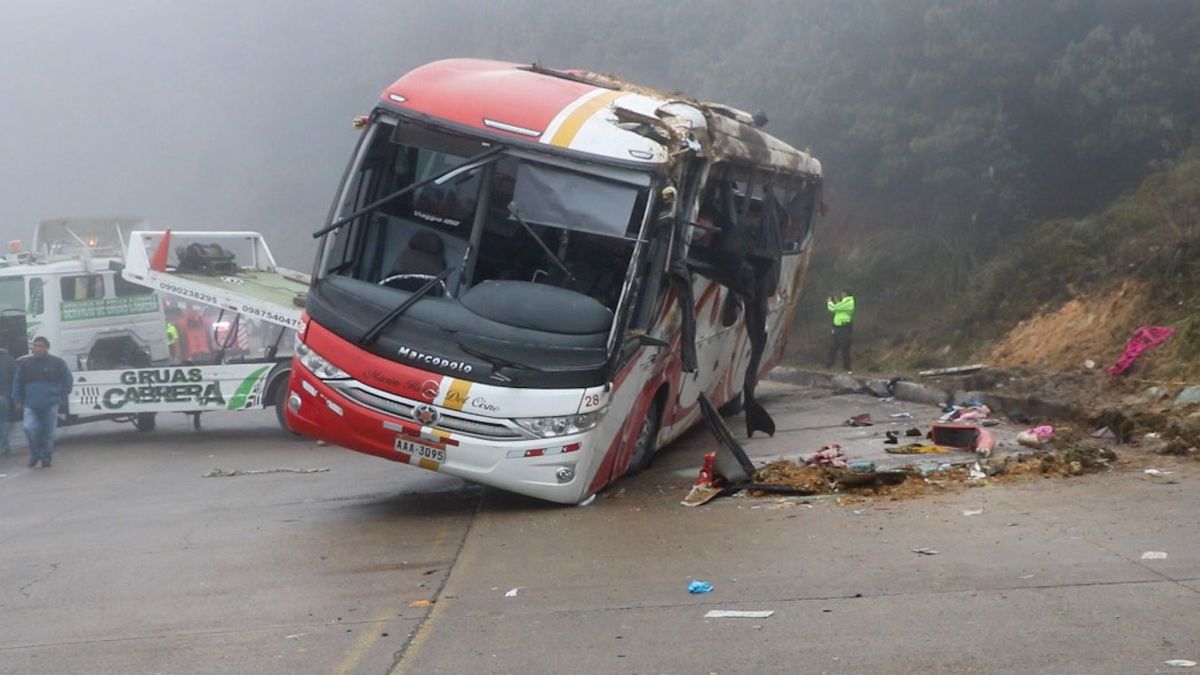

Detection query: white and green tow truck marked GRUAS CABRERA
xmin=0 ymin=217 xmax=308 ymax=431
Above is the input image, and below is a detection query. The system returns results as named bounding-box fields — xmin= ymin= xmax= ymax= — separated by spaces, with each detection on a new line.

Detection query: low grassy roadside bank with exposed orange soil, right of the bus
xmin=791 ymin=150 xmax=1200 ymax=380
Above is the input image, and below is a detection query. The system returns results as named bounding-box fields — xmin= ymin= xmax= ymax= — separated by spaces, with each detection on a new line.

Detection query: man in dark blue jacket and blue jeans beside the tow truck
xmin=12 ymin=336 xmax=74 ymax=467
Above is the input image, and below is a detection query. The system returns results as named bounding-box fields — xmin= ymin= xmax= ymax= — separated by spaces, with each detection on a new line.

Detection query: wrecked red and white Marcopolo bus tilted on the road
xmin=287 ymin=59 xmax=821 ymax=503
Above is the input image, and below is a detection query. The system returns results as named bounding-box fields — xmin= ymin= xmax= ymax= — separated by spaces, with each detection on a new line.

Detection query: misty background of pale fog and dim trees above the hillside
xmin=0 ymin=0 xmax=1200 ymax=279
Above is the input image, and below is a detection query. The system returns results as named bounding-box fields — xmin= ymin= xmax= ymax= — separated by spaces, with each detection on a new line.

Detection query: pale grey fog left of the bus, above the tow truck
xmin=0 ymin=0 xmax=468 ymax=269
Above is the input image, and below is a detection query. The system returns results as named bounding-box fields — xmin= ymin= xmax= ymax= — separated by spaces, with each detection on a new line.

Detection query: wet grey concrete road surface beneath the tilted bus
xmin=0 ymin=387 xmax=1200 ymax=674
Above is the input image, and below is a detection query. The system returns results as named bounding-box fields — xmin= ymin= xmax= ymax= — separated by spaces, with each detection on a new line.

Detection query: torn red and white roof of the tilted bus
xmin=380 ymin=59 xmax=821 ymax=175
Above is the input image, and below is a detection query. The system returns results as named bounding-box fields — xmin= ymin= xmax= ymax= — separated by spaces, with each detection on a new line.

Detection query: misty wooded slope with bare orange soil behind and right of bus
xmin=439 ymin=0 xmax=1200 ymax=377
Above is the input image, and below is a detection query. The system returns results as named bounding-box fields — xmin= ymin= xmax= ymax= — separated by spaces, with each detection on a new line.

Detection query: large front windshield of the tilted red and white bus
xmin=310 ymin=117 xmax=653 ymax=380
